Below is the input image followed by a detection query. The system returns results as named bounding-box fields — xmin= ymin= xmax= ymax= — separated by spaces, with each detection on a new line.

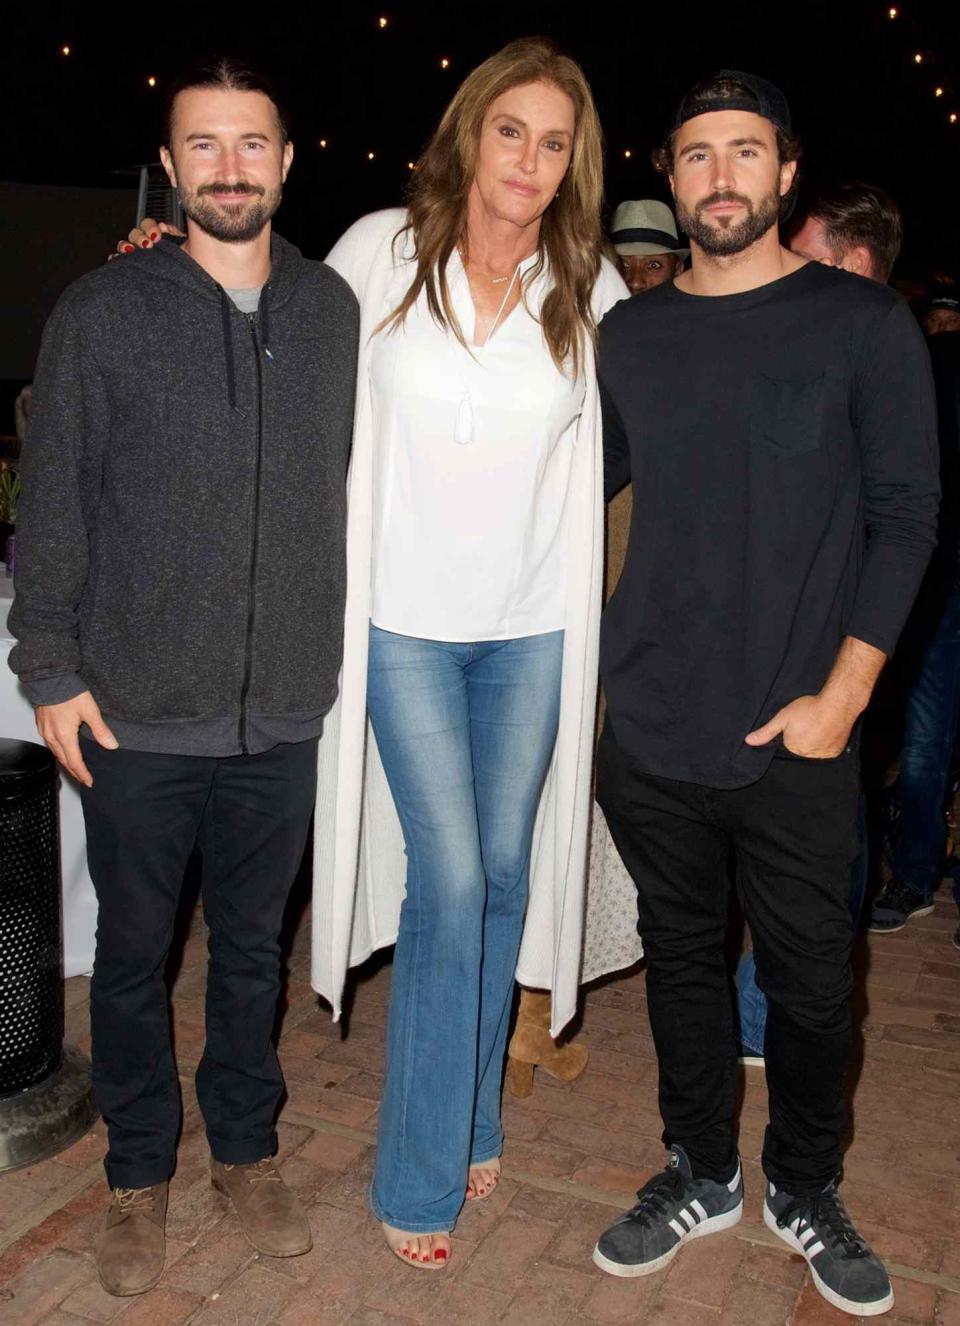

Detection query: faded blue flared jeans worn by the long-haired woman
xmin=367 ymin=625 xmax=564 ymax=1233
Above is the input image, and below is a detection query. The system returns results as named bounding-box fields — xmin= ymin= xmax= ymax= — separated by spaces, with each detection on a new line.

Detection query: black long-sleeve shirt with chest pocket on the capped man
xmin=599 ymin=263 xmax=939 ymax=788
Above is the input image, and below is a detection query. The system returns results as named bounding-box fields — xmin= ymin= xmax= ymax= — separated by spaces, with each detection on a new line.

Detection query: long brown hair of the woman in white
xmin=381 ymin=37 xmax=603 ymax=375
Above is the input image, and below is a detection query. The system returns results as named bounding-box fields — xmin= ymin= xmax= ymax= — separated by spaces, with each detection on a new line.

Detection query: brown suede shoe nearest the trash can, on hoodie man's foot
xmin=97 ymin=1183 xmax=167 ymax=1298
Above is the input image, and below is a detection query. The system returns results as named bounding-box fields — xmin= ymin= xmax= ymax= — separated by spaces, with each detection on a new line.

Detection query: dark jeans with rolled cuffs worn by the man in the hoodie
xmin=82 ymin=740 xmax=317 ymax=1188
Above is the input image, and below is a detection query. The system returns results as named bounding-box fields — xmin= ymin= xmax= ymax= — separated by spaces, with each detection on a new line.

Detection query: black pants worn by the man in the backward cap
xmin=597 ymin=721 xmax=859 ymax=1193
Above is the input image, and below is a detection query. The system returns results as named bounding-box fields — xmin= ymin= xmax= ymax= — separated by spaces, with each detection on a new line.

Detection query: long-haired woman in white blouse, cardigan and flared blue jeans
xmin=313 ymin=38 xmax=627 ymax=1270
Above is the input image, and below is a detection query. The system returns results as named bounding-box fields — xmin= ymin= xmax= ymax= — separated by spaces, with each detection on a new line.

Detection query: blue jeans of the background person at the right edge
xmin=891 ymin=589 xmax=960 ymax=902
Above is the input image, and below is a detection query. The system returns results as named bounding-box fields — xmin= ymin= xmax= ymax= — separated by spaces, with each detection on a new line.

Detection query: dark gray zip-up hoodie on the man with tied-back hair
xmin=9 ymin=235 xmax=359 ymax=756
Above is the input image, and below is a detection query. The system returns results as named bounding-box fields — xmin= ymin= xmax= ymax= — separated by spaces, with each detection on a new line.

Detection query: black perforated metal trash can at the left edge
xmin=0 ymin=739 xmax=97 ymax=1172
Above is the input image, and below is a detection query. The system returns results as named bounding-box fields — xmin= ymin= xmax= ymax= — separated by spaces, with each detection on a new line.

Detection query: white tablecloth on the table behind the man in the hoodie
xmin=0 ymin=580 xmax=97 ymax=976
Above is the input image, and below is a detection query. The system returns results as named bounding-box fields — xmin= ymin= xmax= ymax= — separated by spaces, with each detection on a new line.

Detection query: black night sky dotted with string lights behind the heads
xmin=0 ymin=0 xmax=960 ymax=389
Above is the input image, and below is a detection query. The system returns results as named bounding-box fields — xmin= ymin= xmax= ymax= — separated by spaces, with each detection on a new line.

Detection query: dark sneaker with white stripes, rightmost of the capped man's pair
xmin=764 ymin=1183 xmax=894 ymax=1317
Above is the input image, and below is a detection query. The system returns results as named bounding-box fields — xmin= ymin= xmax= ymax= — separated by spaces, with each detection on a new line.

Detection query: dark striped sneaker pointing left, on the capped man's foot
xmin=593 ymin=1146 xmax=744 ymax=1276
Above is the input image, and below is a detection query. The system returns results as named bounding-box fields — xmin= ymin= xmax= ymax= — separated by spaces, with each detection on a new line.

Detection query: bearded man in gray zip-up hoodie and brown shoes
xmin=11 ymin=60 xmax=359 ymax=1294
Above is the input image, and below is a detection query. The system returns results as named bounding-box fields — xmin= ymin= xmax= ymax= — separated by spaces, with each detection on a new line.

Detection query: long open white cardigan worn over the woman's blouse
xmin=312 ymin=208 xmax=629 ymax=1034
